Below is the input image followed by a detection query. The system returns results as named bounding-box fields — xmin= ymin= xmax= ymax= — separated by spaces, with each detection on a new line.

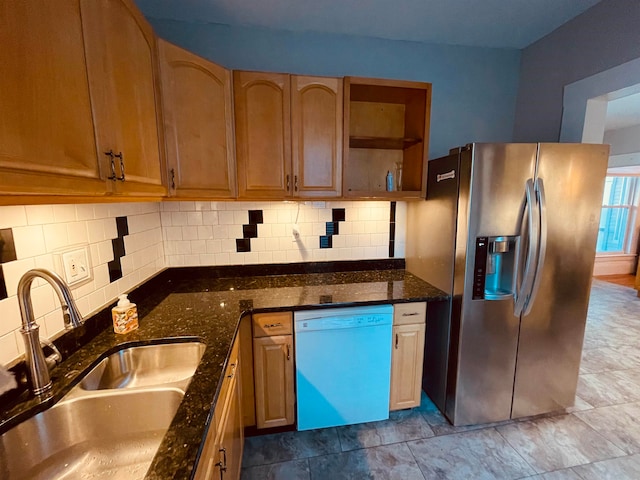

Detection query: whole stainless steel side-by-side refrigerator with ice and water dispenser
xmin=406 ymin=143 xmax=609 ymax=425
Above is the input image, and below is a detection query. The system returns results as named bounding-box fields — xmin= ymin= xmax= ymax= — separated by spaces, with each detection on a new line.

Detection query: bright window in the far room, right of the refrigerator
xmin=596 ymin=177 xmax=638 ymax=253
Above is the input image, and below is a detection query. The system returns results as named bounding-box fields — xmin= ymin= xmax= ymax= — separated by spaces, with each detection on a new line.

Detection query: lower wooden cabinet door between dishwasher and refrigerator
xmin=389 ymin=323 xmax=425 ymax=410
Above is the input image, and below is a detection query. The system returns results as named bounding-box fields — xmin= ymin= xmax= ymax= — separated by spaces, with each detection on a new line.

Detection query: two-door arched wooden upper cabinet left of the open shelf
xmin=233 ymin=71 xmax=343 ymax=198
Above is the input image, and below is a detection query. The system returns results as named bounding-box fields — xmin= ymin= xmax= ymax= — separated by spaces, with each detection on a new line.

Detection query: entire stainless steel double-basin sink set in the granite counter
xmin=0 ymin=341 xmax=205 ymax=480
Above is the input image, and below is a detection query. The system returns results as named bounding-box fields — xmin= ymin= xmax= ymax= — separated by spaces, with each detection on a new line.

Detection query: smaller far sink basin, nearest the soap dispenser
xmin=80 ymin=342 xmax=206 ymax=392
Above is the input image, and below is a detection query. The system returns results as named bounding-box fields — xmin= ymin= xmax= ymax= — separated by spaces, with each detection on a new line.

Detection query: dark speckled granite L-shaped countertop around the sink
xmin=0 ymin=266 xmax=447 ymax=479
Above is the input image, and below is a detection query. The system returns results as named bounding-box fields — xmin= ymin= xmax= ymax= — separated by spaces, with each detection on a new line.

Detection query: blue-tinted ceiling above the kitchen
xmin=136 ymin=0 xmax=600 ymax=49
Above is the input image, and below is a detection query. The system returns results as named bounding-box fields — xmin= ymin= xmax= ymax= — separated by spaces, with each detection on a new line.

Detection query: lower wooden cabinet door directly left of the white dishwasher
xmin=253 ymin=335 xmax=295 ymax=428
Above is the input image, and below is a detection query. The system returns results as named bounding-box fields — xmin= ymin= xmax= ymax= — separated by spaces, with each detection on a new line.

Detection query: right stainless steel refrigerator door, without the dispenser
xmin=512 ymin=144 xmax=609 ymax=418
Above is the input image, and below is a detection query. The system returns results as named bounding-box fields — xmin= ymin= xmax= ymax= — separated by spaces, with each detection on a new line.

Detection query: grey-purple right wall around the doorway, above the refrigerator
xmin=514 ymin=0 xmax=640 ymax=142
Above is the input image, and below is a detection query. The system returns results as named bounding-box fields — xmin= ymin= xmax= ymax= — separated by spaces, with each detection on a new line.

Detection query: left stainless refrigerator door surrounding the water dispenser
xmin=446 ymin=144 xmax=536 ymax=425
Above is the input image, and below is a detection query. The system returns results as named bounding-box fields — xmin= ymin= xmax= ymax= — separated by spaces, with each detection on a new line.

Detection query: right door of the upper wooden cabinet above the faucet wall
xmin=82 ymin=0 xmax=166 ymax=195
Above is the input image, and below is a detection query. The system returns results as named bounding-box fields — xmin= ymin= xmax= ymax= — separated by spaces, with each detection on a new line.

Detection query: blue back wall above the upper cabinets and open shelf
xmin=149 ymin=18 xmax=520 ymax=158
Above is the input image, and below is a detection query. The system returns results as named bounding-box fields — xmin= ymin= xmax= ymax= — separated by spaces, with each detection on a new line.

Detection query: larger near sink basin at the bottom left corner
xmin=0 ymin=389 xmax=183 ymax=480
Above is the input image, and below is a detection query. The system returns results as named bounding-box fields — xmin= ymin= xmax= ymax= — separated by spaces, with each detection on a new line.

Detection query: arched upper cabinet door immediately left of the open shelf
xmin=291 ymin=76 xmax=343 ymax=197
